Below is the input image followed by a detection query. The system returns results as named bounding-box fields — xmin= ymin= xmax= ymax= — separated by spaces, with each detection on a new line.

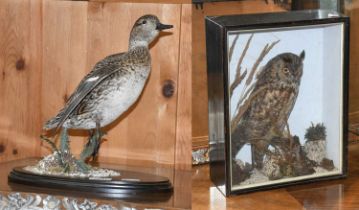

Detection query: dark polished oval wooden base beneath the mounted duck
xmin=8 ymin=167 xmax=173 ymax=200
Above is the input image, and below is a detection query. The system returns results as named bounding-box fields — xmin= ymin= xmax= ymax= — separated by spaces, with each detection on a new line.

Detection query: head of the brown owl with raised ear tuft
xmin=257 ymin=50 xmax=305 ymax=87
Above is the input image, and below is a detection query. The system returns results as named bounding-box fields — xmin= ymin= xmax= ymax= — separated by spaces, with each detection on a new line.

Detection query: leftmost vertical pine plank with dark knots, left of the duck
xmin=0 ymin=0 xmax=42 ymax=161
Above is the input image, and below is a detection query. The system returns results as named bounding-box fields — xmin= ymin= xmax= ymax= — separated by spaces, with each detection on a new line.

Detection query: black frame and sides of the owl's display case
xmin=205 ymin=10 xmax=349 ymax=196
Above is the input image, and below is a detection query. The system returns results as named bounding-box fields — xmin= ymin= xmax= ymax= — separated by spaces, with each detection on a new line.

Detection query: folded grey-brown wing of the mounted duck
xmin=43 ymin=53 xmax=125 ymax=130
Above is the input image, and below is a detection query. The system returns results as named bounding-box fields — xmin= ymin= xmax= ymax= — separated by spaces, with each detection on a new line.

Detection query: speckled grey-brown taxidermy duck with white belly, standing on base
xmin=43 ymin=15 xmax=173 ymax=171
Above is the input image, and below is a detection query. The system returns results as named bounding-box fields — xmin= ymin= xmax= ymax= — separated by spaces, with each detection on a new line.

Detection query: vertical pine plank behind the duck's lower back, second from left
xmin=38 ymin=0 xmax=88 ymax=155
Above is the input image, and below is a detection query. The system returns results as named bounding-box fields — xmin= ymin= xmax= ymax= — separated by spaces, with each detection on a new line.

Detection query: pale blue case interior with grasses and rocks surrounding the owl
xmin=227 ymin=23 xmax=343 ymax=190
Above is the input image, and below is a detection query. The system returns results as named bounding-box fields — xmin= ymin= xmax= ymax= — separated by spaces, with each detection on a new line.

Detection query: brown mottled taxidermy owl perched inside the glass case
xmin=232 ymin=51 xmax=305 ymax=169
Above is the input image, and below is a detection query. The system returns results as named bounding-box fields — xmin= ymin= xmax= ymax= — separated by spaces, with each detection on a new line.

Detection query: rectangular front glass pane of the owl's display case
xmin=227 ymin=23 xmax=343 ymax=190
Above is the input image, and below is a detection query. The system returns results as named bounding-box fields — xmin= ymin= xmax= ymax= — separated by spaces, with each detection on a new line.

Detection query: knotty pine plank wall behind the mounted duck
xmin=0 ymin=0 xmax=191 ymax=169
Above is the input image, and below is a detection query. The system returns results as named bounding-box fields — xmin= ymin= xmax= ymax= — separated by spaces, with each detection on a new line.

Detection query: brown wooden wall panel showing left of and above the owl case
xmin=192 ymin=0 xmax=284 ymax=147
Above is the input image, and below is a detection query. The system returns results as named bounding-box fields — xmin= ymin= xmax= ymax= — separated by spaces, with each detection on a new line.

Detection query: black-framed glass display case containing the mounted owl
xmin=206 ymin=10 xmax=349 ymax=195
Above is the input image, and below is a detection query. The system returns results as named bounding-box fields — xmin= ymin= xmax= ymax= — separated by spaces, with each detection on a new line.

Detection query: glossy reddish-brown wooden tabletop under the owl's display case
xmin=192 ymin=143 xmax=359 ymax=210
